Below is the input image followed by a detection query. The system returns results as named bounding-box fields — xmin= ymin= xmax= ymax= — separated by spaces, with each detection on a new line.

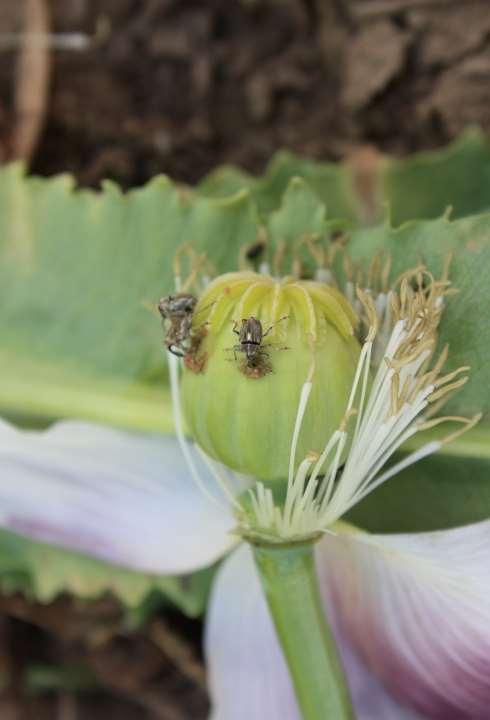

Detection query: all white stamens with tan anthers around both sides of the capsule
xmin=168 ymin=258 xmax=479 ymax=542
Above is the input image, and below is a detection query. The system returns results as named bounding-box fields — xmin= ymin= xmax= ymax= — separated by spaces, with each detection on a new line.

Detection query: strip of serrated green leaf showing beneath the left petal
xmin=0 ymin=530 xmax=210 ymax=616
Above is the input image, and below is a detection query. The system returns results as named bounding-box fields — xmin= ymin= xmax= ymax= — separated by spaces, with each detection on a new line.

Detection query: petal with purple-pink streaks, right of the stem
xmin=320 ymin=521 xmax=490 ymax=720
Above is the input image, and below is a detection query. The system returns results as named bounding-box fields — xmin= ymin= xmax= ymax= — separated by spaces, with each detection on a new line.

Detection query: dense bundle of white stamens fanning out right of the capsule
xmin=247 ymin=276 xmax=478 ymax=540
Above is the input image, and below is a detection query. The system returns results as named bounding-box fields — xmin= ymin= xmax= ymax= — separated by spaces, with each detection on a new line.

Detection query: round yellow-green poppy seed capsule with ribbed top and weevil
xmin=182 ymin=272 xmax=360 ymax=480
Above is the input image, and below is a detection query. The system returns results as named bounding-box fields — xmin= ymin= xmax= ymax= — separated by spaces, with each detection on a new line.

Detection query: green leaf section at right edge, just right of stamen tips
xmin=348 ymin=214 xmax=490 ymax=415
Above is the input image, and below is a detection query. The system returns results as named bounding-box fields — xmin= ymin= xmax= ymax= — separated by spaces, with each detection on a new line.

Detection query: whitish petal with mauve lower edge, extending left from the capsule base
xmin=0 ymin=422 xmax=236 ymax=574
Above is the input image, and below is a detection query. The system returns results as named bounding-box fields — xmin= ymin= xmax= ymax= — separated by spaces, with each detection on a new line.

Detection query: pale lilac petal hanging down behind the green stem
xmin=206 ymin=545 xmax=420 ymax=720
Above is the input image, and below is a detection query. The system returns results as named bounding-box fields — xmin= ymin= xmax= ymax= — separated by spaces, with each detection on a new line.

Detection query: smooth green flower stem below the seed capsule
xmin=253 ymin=543 xmax=355 ymax=720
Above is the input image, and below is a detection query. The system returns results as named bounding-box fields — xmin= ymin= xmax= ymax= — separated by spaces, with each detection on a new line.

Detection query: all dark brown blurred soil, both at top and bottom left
xmin=0 ymin=0 xmax=490 ymax=720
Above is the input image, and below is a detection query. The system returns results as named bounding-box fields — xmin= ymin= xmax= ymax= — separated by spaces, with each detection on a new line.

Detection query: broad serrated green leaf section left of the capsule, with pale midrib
xmin=0 ymin=165 xmax=257 ymax=429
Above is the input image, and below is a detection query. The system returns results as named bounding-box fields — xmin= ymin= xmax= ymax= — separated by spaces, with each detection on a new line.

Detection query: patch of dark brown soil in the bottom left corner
xmin=0 ymin=595 xmax=208 ymax=720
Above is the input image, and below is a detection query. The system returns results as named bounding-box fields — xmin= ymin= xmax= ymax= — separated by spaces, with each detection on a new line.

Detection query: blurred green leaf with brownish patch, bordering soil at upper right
xmin=199 ymin=129 xmax=490 ymax=226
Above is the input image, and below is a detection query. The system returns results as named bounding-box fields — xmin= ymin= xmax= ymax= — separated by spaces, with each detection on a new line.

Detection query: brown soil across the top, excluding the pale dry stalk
xmin=0 ymin=0 xmax=490 ymax=186
